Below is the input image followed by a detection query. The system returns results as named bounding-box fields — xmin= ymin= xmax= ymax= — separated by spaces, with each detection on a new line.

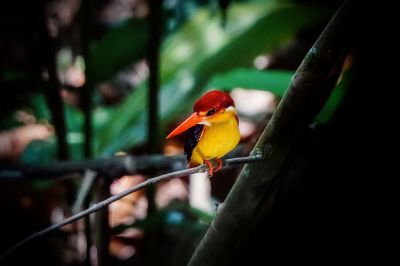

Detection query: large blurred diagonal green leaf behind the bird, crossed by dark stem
xmin=95 ymin=1 xmax=330 ymax=155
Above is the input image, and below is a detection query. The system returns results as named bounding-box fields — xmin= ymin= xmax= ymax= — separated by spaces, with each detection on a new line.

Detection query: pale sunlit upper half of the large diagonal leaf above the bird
xmin=161 ymin=1 xmax=277 ymax=82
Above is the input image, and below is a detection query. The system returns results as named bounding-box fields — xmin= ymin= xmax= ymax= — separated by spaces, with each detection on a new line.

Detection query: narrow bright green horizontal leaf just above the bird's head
xmin=209 ymin=68 xmax=293 ymax=97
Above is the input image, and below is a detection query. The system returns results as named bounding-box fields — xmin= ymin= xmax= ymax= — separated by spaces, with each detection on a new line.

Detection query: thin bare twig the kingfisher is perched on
xmin=0 ymin=154 xmax=262 ymax=261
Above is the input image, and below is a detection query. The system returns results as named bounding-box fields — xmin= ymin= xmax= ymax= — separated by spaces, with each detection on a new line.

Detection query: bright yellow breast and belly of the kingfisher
xmin=190 ymin=113 xmax=240 ymax=165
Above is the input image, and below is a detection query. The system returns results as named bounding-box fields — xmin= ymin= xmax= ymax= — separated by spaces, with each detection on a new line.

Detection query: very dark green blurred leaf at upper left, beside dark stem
xmin=87 ymin=19 xmax=148 ymax=82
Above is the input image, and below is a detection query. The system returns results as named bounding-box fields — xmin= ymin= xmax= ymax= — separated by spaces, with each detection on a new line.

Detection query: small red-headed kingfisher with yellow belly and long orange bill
xmin=167 ymin=90 xmax=240 ymax=177
